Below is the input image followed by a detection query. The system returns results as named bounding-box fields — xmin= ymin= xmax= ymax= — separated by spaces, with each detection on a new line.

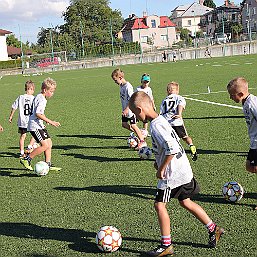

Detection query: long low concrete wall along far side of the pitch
xmin=0 ymin=40 xmax=257 ymax=76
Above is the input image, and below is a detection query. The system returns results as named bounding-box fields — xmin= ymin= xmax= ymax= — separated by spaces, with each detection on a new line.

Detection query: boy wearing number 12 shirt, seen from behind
xmin=160 ymin=81 xmax=197 ymax=161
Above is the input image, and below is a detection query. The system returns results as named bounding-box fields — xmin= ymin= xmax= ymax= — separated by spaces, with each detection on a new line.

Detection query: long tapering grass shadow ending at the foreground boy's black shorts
xmin=54 ymin=185 xmax=156 ymax=200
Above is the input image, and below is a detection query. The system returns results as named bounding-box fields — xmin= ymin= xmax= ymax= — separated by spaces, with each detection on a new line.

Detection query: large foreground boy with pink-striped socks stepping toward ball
xmin=129 ymin=92 xmax=224 ymax=256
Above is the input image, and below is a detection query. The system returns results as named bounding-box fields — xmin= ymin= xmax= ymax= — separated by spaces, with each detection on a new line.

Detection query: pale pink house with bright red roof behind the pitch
xmin=120 ymin=14 xmax=179 ymax=49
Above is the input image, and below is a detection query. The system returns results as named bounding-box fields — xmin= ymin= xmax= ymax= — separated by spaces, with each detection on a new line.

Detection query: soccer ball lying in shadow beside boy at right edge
xmin=222 ymin=181 xmax=244 ymax=202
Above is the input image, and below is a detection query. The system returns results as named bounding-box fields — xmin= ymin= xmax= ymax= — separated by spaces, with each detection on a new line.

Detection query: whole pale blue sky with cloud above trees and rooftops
xmin=0 ymin=0 xmax=241 ymax=43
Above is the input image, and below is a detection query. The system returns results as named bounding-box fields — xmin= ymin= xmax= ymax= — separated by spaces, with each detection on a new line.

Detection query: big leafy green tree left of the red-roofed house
xmin=61 ymin=0 xmax=123 ymax=49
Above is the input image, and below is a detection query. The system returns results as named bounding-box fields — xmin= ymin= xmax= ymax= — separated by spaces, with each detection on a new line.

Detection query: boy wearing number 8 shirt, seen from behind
xmin=9 ymin=80 xmax=35 ymax=157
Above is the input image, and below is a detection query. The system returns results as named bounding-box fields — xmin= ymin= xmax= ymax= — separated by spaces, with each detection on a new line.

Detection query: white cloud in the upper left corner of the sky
xmin=0 ymin=0 xmax=69 ymax=24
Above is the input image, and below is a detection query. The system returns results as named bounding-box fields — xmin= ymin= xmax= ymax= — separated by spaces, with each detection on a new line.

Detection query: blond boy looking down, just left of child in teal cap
xmin=111 ymin=69 xmax=146 ymax=149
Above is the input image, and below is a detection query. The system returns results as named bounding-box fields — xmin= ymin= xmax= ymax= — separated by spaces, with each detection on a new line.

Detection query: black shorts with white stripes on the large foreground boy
xmin=155 ymin=178 xmax=200 ymax=203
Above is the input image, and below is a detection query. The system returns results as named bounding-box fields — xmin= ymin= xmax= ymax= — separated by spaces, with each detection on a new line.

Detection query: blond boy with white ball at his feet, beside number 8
xmin=20 ymin=78 xmax=61 ymax=170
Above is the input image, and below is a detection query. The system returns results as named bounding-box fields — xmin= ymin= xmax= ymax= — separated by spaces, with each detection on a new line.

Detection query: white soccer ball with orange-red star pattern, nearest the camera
xmin=96 ymin=226 xmax=122 ymax=252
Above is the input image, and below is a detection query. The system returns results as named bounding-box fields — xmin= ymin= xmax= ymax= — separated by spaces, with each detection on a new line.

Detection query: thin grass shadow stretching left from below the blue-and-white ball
xmin=61 ymin=153 xmax=145 ymax=162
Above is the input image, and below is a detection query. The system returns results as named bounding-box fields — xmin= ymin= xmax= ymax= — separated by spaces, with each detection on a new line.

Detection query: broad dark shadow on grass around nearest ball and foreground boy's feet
xmin=0 ymin=222 xmax=207 ymax=254
